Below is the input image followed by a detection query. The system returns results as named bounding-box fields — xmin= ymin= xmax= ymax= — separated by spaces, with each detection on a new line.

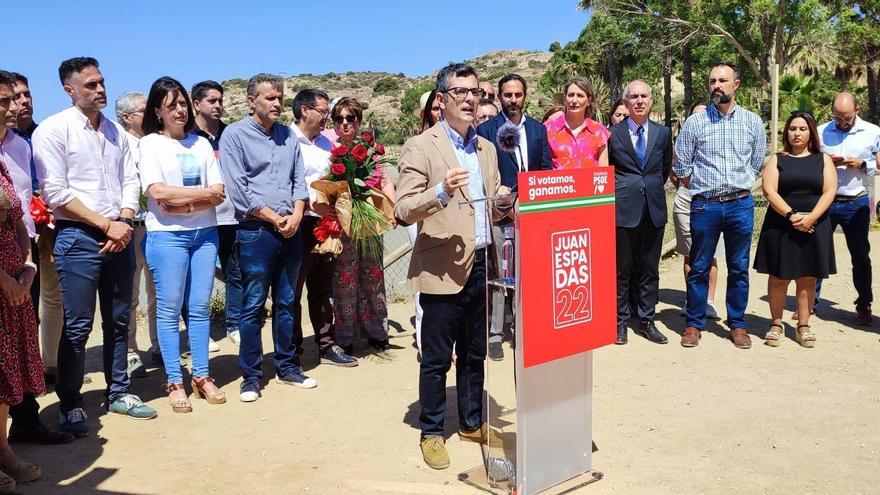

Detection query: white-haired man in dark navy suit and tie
xmin=608 ymin=80 xmax=672 ymax=344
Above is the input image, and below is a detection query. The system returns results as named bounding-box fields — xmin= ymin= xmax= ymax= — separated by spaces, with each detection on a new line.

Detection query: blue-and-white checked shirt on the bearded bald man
xmin=672 ymin=105 xmax=767 ymax=198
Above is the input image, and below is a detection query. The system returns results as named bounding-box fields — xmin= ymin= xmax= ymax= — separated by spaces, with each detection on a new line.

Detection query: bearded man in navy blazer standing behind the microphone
xmin=477 ymin=74 xmax=553 ymax=361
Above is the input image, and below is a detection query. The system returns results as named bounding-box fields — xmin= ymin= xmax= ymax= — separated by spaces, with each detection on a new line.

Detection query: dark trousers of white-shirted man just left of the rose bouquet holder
xmin=293 ymin=216 xmax=335 ymax=352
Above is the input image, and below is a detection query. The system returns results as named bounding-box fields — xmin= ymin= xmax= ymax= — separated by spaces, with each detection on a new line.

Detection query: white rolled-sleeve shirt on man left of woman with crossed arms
xmin=32 ymin=107 xmax=140 ymax=220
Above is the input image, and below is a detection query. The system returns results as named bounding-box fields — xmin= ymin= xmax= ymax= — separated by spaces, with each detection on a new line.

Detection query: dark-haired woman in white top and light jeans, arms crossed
xmin=140 ymin=77 xmax=226 ymax=413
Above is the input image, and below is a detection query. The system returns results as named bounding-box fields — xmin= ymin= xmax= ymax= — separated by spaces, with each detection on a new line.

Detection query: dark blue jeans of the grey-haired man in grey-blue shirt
xmin=232 ymin=222 xmax=303 ymax=385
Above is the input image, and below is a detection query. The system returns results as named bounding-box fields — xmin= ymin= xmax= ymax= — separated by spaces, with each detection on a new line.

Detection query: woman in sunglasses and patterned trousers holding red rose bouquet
xmin=330 ymin=97 xmax=395 ymax=356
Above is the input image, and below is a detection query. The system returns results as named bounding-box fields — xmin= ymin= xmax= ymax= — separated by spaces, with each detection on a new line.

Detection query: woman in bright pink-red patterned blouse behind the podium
xmin=545 ymin=77 xmax=611 ymax=169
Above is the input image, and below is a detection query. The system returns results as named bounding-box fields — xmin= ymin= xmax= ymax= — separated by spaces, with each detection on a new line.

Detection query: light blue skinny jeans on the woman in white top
xmin=144 ymin=227 xmax=218 ymax=383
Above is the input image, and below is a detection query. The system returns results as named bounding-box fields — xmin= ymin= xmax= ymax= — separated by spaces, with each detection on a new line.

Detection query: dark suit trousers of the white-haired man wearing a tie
xmin=617 ymin=208 xmax=663 ymax=328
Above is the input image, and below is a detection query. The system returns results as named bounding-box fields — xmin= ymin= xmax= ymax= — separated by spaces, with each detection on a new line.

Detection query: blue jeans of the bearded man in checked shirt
xmin=687 ymin=196 xmax=755 ymax=330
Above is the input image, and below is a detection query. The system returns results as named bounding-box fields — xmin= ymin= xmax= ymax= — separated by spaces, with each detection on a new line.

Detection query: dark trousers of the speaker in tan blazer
xmin=419 ymin=255 xmax=486 ymax=436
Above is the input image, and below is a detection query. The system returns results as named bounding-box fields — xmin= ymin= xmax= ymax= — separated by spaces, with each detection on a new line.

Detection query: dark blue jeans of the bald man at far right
xmin=816 ymin=196 xmax=874 ymax=307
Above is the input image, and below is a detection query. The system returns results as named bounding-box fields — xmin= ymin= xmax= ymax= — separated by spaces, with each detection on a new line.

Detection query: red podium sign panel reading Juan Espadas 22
xmin=517 ymin=167 xmax=617 ymax=368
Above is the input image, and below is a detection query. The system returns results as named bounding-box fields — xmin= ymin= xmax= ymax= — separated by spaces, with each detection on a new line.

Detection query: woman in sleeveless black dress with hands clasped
xmin=755 ymin=111 xmax=837 ymax=347
